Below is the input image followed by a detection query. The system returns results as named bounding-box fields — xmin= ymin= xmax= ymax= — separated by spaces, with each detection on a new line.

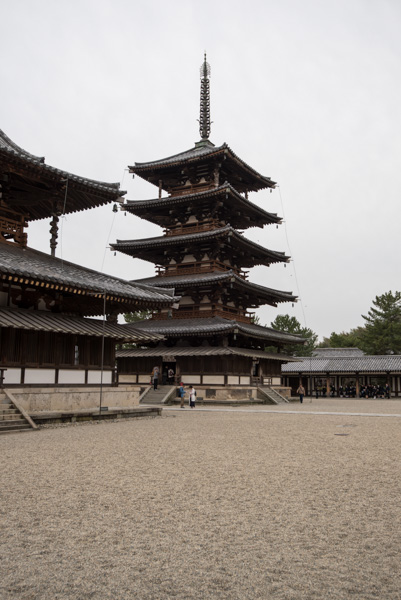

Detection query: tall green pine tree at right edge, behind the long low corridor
xmin=361 ymin=291 xmax=401 ymax=354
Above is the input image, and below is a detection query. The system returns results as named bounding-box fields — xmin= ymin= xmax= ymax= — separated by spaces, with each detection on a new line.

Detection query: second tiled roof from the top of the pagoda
xmin=125 ymin=182 xmax=282 ymax=229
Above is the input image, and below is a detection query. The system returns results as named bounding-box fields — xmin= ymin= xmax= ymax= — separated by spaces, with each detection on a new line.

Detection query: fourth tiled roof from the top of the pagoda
xmin=136 ymin=270 xmax=297 ymax=306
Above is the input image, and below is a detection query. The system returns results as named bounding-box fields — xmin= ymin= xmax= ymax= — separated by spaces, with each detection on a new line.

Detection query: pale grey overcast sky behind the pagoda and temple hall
xmin=0 ymin=0 xmax=401 ymax=339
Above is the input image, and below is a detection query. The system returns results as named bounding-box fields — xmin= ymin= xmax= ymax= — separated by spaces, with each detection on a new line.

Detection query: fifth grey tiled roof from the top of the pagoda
xmin=123 ymin=317 xmax=305 ymax=344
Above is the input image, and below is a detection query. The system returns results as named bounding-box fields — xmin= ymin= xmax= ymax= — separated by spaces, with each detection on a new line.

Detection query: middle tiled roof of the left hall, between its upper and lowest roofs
xmin=0 ymin=242 xmax=178 ymax=310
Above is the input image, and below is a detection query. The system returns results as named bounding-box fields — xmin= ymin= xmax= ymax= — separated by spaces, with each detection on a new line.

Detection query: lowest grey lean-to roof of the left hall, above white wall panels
xmin=0 ymin=308 xmax=164 ymax=343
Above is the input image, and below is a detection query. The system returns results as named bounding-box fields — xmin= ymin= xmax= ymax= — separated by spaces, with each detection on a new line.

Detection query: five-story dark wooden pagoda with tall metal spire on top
xmin=112 ymin=56 xmax=303 ymax=397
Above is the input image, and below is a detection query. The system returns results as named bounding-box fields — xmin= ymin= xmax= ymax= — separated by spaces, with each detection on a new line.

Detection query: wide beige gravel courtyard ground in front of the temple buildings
xmin=0 ymin=400 xmax=401 ymax=600
